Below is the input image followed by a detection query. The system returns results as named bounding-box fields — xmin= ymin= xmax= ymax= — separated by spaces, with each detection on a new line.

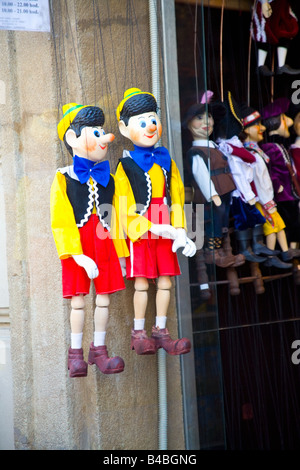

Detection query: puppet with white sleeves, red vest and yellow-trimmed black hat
xmin=218 ymin=92 xmax=290 ymax=269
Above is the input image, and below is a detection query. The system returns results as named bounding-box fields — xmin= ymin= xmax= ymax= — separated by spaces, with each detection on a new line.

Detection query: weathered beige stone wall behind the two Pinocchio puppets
xmin=0 ymin=0 xmax=184 ymax=450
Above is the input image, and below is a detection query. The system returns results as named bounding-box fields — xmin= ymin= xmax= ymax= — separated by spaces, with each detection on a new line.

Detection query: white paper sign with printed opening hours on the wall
xmin=0 ymin=0 xmax=50 ymax=32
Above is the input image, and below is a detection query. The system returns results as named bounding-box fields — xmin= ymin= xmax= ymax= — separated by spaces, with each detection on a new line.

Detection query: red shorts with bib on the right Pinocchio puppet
xmin=126 ymin=198 xmax=181 ymax=279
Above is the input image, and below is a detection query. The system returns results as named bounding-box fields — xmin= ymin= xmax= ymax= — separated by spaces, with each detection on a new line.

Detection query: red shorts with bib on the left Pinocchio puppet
xmin=61 ymin=214 xmax=125 ymax=299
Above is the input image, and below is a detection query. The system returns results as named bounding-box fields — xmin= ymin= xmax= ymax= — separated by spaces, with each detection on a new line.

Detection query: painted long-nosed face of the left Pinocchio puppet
xmin=66 ymin=126 xmax=115 ymax=162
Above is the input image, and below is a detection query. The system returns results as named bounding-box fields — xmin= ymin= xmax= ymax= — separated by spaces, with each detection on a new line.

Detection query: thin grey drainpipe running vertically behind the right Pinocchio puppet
xmin=149 ymin=0 xmax=168 ymax=450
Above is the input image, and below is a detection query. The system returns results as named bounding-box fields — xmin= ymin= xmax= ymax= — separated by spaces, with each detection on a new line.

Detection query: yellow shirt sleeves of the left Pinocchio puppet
xmin=50 ymin=171 xmax=129 ymax=259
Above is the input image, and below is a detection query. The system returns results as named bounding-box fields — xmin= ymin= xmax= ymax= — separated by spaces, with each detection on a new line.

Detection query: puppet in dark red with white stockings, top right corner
xmin=250 ymin=0 xmax=300 ymax=76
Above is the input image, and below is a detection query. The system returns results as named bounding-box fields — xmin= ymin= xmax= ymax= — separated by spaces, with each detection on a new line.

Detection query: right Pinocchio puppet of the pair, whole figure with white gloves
xmin=115 ymin=88 xmax=196 ymax=355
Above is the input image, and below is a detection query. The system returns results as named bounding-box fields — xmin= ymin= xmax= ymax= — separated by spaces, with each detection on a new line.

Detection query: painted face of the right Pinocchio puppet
xmin=120 ymin=111 xmax=162 ymax=147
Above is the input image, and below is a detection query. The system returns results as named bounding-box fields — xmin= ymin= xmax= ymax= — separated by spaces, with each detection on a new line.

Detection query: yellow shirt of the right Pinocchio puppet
xmin=115 ymin=160 xmax=186 ymax=242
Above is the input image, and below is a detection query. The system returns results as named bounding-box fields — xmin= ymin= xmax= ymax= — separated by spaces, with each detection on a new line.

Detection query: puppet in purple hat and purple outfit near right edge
xmin=260 ymin=98 xmax=300 ymax=255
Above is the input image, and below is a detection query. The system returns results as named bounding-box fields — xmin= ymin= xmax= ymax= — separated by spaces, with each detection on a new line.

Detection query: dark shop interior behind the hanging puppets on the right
xmin=176 ymin=1 xmax=300 ymax=450
